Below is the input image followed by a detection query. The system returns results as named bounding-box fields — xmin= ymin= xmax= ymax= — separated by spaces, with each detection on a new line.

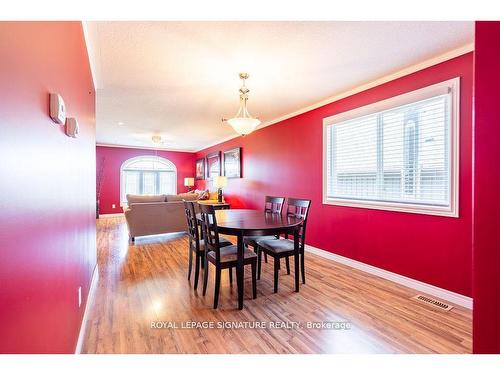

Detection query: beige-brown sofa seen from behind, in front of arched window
xmin=123 ymin=191 xmax=222 ymax=241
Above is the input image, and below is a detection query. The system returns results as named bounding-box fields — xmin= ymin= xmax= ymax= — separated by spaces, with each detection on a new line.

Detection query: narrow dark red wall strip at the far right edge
xmin=473 ymin=22 xmax=500 ymax=353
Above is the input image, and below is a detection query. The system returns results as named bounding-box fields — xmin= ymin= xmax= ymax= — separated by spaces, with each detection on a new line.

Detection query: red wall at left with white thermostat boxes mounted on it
xmin=0 ymin=22 xmax=96 ymax=353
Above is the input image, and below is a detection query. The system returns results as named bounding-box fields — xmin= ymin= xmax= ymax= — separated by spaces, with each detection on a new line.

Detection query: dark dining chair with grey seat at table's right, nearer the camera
xmin=257 ymin=198 xmax=311 ymax=293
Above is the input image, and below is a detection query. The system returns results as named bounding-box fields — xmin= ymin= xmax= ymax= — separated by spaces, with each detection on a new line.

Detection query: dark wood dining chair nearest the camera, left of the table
xmin=200 ymin=204 xmax=257 ymax=309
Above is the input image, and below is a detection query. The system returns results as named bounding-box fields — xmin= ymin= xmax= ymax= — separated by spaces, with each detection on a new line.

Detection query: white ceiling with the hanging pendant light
xmin=85 ymin=21 xmax=473 ymax=151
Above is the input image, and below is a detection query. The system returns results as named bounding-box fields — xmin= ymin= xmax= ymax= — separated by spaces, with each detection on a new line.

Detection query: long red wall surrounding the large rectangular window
xmin=197 ymin=53 xmax=473 ymax=296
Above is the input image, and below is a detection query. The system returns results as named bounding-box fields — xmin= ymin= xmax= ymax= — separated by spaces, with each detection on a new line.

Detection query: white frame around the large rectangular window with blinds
xmin=323 ymin=77 xmax=460 ymax=217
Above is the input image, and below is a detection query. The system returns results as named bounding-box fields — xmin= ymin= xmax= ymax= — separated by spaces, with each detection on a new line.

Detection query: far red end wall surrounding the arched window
xmin=96 ymin=146 xmax=196 ymax=214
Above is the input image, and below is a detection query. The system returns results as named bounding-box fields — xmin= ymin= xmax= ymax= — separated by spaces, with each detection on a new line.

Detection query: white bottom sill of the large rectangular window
xmin=323 ymin=198 xmax=459 ymax=218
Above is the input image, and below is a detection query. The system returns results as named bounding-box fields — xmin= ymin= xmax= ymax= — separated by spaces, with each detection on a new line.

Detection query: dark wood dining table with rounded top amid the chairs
xmin=197 ymin=209 xmax=302 ymax=310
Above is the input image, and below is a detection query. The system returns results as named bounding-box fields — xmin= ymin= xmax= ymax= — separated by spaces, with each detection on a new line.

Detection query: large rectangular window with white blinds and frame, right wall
xmin=323 ymin=78 xmax=459 ymax=217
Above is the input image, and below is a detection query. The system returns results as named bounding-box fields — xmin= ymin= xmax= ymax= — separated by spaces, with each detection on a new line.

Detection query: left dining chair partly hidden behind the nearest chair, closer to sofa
xmin=183 ymin=200 xmax=232 ymax=290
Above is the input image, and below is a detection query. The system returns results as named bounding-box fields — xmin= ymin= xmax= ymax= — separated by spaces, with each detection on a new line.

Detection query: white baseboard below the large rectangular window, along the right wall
xmin=305 ymin=245 xmax=472 ymax=310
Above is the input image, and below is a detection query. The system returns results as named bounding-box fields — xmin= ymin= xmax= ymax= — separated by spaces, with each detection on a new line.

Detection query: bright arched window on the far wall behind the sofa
xmin=120 ymin=156 xmax=177 ymax=204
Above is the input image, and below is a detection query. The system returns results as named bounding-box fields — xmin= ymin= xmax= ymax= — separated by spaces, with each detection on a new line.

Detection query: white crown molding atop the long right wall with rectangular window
xmin=194 ymin=43 xmax=474 ymax=152
